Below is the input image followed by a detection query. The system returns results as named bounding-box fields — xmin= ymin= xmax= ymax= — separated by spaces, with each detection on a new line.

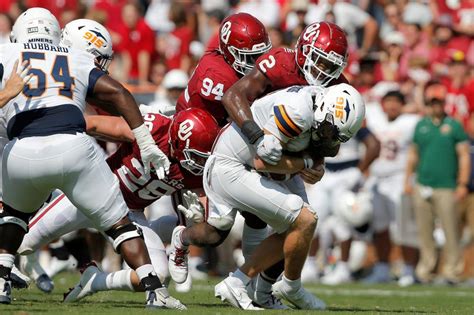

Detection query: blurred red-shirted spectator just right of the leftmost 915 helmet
xmin=117 ymin=3 xmax=155 ymax=85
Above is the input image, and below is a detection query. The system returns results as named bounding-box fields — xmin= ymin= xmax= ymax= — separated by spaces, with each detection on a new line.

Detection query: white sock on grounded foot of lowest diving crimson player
xmin=91 ymin=269 xmax=135 ymax=292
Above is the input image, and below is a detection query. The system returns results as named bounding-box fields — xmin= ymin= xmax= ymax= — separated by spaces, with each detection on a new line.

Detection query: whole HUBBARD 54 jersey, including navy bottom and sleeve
xmin=0 ymin=43 xmax=103 ymax=139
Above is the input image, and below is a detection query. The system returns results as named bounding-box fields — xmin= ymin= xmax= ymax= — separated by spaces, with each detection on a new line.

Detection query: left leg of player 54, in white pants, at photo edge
xmin=0 ymin=138 xmax=56 ymax=304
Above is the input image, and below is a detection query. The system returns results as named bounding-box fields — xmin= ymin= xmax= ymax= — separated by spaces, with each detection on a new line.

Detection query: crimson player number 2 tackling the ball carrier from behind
xmin=169 ymin=22 xmax=348 ymax=308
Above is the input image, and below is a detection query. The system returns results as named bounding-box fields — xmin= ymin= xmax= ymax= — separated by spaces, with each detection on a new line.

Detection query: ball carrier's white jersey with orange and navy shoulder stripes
xmin=213 ymin=86 xmax=318 ymax=166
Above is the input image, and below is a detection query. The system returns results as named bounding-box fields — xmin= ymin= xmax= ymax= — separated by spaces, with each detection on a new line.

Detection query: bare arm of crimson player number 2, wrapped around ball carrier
xmin=222 ymin=66 xmax=270 ymax=144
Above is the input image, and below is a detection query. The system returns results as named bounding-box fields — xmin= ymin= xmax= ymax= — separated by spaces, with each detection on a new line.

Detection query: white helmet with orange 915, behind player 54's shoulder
xmin=61 ymin=19 xmax=114 ymax=71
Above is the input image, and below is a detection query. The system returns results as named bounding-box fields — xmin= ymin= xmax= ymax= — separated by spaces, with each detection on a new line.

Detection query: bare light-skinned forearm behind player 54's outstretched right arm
xmin=84 ymin=115 xmax=135 ymax=142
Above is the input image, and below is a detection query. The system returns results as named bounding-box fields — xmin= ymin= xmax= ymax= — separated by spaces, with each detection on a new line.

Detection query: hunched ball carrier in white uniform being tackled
xmin=204 ymin=84 xmax=365 ymax=309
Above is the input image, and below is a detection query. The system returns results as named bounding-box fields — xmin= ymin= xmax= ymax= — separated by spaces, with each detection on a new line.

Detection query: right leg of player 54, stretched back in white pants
xmin=60 ymin=135 xmax=184 ymax=309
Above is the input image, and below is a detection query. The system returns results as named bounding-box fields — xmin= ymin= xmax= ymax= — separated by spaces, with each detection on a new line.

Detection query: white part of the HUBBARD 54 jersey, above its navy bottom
xmin=0 ymin=43 xmax=95 ymax=123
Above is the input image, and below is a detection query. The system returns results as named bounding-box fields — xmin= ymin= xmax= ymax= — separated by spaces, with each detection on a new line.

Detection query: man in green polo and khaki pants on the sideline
xmin=405 ymin=82 xmax=470 ymax=283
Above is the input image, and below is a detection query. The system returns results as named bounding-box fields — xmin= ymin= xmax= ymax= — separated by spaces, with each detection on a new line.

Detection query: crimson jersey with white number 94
xmin=176 ymin=50 xmax=240 ymax=127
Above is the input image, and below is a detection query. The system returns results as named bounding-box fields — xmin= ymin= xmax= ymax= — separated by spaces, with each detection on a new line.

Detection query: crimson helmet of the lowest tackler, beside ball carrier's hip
xmin=168 ymin=108 xmax=219 ymax=175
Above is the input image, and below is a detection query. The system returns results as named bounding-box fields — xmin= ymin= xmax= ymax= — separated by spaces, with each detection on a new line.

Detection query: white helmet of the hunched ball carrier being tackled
xmin=312 ymin=83 xmax=365 ymax=142
